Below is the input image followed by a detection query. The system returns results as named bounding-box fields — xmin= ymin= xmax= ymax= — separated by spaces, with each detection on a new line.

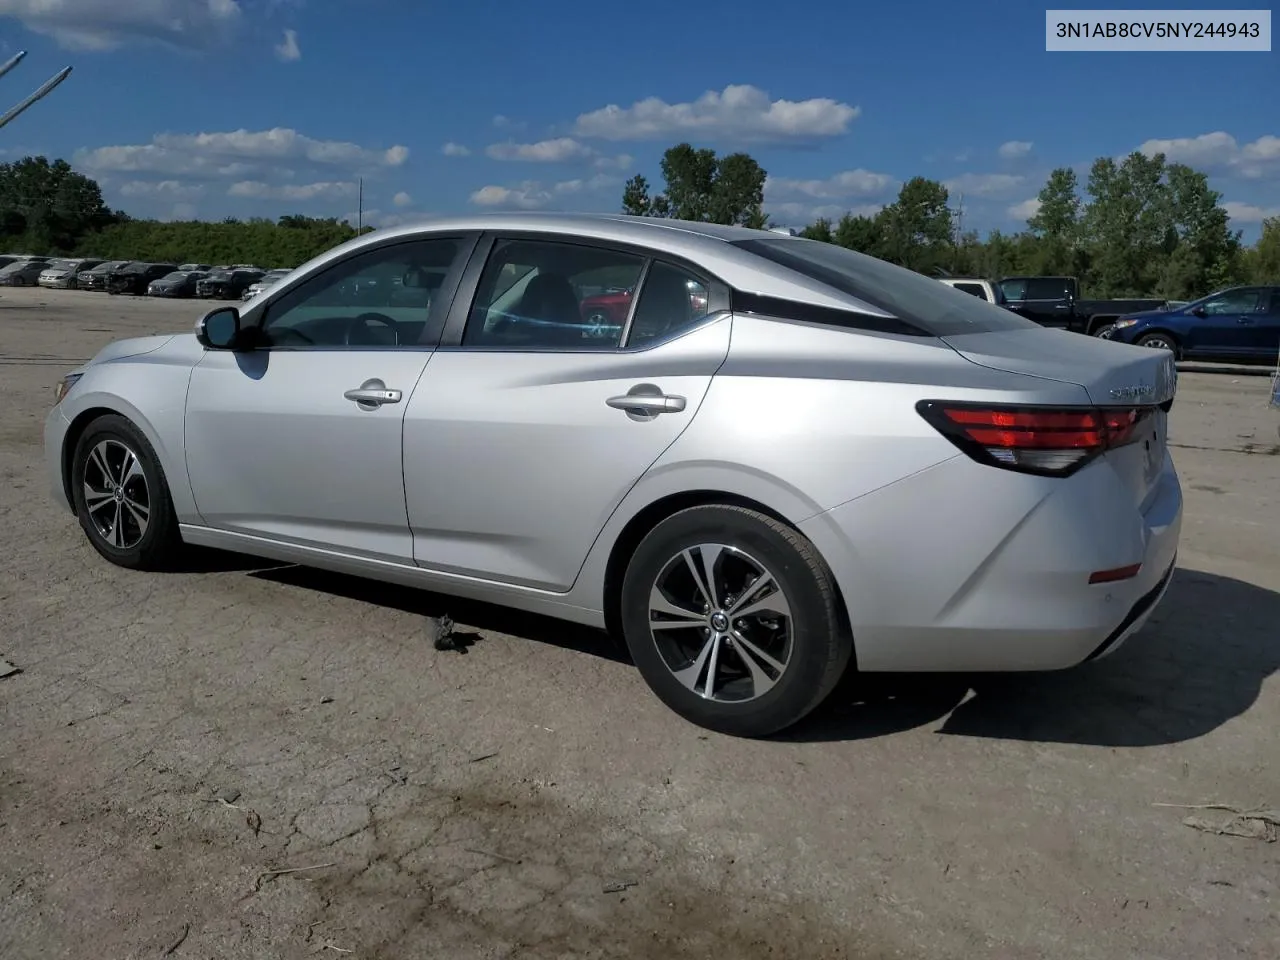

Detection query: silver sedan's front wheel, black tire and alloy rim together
xmin=72 ymin=413 xmax=182 ymax=571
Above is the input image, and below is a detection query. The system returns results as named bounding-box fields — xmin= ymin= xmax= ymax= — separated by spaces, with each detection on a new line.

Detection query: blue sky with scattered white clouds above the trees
xmin=0 ymin=0 xmax=1280 ymax=238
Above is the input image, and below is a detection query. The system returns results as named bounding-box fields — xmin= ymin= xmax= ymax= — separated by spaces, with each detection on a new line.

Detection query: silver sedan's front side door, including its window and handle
xmin=186 ymin=236 xmax=475 ymax=563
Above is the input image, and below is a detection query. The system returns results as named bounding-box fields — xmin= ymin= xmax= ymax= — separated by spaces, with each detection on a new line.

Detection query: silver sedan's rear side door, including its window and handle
xmin=404 ymin=236 xmax=730 ymax=591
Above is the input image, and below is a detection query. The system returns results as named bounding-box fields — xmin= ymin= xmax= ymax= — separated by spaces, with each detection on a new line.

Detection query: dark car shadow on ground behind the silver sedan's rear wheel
xmin=781 ymin=568 xmax=1280 ymax=746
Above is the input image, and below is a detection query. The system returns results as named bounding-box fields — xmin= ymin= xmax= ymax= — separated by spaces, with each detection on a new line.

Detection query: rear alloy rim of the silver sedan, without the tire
xmin=649 ymin=543 xmax=794 ymax=703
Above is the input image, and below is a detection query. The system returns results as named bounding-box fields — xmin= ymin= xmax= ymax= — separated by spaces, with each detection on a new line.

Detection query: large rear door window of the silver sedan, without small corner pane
xmin=462 ymin=241 xmax=644 ymax=349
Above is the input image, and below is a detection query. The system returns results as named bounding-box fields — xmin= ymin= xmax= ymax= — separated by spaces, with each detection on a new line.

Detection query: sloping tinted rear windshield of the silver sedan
xmin=735 ymin=237 xmax=1037 ymax=337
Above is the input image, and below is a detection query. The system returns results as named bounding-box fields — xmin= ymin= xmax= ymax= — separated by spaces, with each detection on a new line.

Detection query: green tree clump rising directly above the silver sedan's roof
xmin=622 ymin=143 xmax=768 ymax=228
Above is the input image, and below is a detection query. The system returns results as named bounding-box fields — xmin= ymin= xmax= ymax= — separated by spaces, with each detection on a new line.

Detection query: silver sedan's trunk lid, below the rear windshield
xmin=942 ymin=329 xmax=1178 ymax=506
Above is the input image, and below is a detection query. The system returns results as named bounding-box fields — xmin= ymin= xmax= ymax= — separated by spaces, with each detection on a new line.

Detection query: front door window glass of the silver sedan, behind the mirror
xmin=262 ymin=238 xmax=462 ymax=347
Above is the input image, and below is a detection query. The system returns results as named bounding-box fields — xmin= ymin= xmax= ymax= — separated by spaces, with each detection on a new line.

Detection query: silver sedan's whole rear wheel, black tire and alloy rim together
xmin=621 ymin=506 xmax=854 ymax=737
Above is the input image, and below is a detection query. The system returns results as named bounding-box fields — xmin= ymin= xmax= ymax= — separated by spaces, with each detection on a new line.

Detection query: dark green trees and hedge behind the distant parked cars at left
xmin=0 ymin=156 xmax=370 ymax=268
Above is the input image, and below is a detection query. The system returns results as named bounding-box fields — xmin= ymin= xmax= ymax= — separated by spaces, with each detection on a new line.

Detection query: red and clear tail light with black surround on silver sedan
xmin=915 ymin=401 xmax=1153 ymax=476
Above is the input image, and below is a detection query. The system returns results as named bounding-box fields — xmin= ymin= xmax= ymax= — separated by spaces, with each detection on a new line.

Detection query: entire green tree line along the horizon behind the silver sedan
xmin=0 ymin=143 xmax=1280 ymax=300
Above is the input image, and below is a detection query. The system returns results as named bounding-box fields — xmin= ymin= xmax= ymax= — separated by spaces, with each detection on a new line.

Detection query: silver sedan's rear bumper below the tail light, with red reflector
xmin=801 ymin=453 xmax=1183 ymax=672
